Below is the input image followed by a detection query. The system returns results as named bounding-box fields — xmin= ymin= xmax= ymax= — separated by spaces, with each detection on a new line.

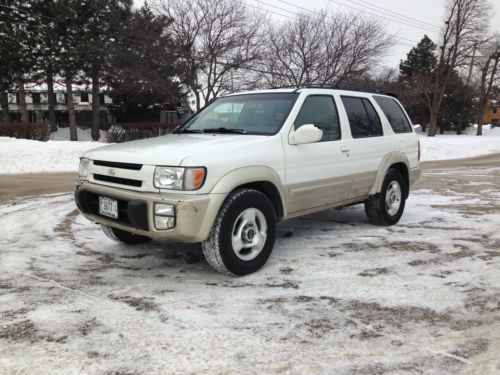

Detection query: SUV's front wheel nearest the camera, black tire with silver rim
xmin=201 ymin=189 xmax=276 ymax=276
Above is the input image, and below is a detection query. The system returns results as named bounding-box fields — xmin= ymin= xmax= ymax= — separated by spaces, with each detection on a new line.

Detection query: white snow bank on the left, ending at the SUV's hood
xmin=0 ymin=137 xmax=103 ymax=175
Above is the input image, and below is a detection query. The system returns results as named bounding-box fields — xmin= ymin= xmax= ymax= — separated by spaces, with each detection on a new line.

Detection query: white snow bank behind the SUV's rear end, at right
xmin=417 ymin=125 xmax=500 ymax=161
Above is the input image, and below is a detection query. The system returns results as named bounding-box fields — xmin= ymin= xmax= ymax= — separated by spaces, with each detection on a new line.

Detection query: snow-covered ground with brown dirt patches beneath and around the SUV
xmin=0 ymin=163 xmax=500 ymax=375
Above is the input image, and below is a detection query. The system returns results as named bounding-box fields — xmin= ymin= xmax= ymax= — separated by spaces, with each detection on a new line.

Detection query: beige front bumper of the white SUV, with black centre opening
xmin=75 ymin=181 xmax=226 ymax=242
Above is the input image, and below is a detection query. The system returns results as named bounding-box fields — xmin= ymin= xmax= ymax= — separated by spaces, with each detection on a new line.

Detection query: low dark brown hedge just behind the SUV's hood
xmin=107 ymin=122 xmax=177 ymax=143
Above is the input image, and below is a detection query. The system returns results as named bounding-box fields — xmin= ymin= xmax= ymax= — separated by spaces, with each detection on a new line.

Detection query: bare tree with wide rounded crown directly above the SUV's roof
xmin=265 ymin=10 xmax=390 ymax=87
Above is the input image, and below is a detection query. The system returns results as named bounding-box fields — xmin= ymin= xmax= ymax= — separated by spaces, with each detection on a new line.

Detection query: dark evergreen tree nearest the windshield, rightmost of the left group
xmin=108 ymin=3 xmax=182 ymax=121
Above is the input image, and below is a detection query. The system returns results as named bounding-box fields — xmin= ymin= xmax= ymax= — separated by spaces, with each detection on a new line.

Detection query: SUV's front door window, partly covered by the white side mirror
xmin=294 ymin=95 xmax=340 ymax=142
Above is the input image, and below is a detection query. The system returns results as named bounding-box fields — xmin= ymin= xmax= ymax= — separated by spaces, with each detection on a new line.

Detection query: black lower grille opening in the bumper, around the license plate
xmin=75 ymin=189 xmax=149 ymax=231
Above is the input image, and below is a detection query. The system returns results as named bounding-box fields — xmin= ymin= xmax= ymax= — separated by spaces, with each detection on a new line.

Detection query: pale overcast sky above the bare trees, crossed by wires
xmin=138 ymin=0 xmax=500 ymax=67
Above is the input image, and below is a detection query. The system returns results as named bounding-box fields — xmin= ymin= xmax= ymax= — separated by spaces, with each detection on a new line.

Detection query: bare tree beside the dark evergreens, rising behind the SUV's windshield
xmin=155 ymin=0 xmax=265 ymax=109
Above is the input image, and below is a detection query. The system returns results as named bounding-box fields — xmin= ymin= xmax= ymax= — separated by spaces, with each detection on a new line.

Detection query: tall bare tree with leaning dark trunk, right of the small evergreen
xmin=428 ymin=0 xmax=490 ymax=137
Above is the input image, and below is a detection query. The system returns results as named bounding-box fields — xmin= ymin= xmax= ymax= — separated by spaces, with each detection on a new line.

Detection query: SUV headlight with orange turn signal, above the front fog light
xmin=153 ymin=167 xmax=206 ymax=190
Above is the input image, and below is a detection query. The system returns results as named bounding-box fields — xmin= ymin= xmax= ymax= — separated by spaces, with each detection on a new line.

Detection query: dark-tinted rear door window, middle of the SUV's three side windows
xmin=342 ymin=96 xmax=383 ymax=138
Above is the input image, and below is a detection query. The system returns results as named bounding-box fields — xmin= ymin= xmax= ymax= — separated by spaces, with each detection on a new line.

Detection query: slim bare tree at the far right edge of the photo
xmin=477 ymin=34 xmax=500 ymax=135
